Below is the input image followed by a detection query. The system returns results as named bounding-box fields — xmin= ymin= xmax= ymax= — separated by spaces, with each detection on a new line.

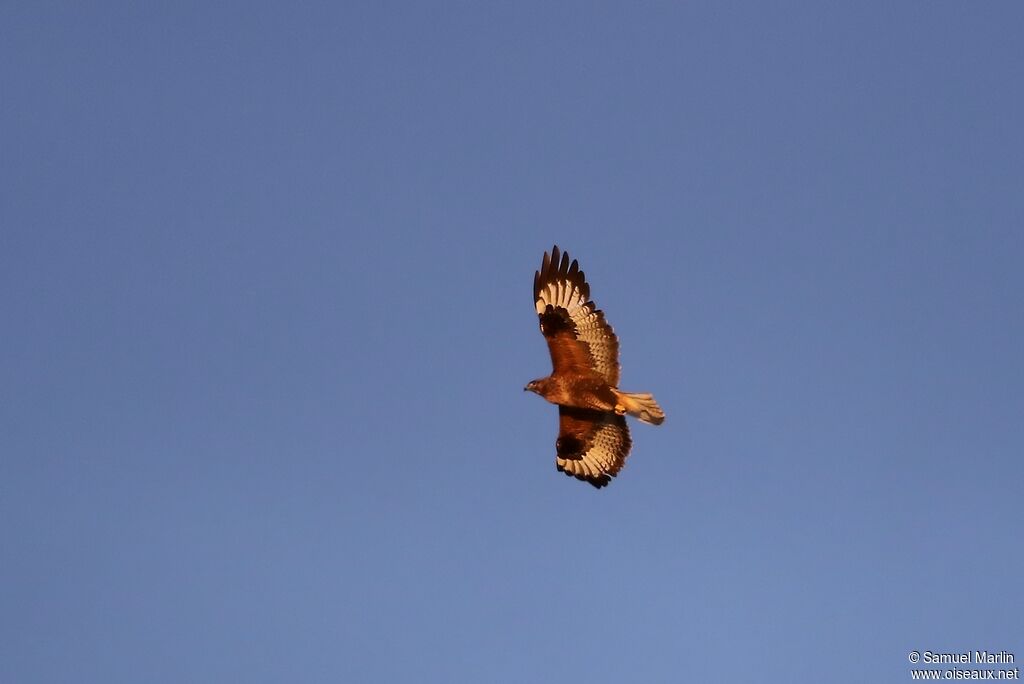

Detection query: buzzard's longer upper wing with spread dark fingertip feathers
xmin=534 ymin=245 xmax=618 ymax=387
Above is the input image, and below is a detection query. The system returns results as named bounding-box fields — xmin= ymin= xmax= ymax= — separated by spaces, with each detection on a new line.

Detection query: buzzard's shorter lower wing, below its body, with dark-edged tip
xmin=555 ymin=407 xmax=633 ymax=488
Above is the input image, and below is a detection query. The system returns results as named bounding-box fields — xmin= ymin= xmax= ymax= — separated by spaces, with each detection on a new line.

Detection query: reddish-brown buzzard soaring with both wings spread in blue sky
xmin=524 ymin=246 xmax=665 ymax=487
